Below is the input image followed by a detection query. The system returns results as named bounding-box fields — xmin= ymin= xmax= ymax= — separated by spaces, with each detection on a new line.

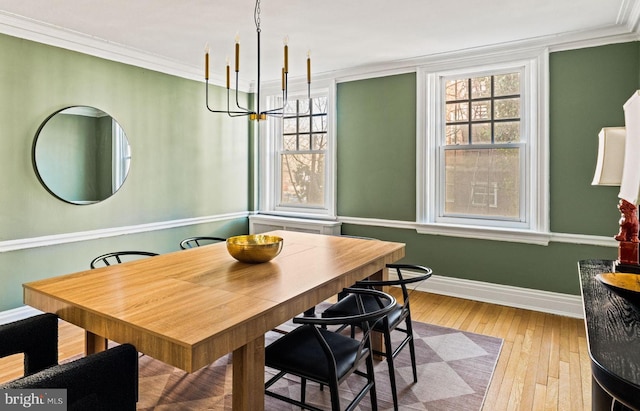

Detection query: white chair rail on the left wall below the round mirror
xmin=0 ymin=212 xmax=249 ymax=253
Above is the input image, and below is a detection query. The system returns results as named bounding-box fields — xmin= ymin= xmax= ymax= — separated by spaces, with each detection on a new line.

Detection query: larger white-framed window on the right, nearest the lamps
xmin=417 ymin=51 xmax=548 ymax=244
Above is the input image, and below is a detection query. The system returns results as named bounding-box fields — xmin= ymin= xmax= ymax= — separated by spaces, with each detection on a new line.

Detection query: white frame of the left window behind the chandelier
xmin=257 ymin=80 xmax=336 ymax=220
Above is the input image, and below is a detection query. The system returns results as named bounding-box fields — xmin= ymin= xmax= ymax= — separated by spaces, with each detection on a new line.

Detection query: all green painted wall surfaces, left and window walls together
xmin=0 ymin=35 xmax=640 ymax=310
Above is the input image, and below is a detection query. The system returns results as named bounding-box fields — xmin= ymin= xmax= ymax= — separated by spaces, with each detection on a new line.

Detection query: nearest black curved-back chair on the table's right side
xmin=265 ymin=289 xmax=396 ymax=411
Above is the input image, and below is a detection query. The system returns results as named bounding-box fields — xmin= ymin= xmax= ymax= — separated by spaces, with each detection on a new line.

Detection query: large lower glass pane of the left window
xmin=281 ymin=154 xmax=325 ymax=207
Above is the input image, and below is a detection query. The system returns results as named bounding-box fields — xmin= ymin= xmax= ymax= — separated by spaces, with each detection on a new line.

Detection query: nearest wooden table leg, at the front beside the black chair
xmin=232 ymin=335 xmax=264 ymax=411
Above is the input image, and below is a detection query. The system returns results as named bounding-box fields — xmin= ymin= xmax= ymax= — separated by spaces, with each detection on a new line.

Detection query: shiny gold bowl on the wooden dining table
xmin=227 ymin=234 xmax=282 ymax=264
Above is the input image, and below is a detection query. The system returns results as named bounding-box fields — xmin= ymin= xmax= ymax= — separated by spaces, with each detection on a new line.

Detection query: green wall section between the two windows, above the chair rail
xmin=336 ymin=74 xmax=416 ymax=221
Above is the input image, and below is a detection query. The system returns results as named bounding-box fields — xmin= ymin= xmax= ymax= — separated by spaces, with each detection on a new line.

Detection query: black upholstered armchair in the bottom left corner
xmin=0 ymin=313 xmax=138 ymax=411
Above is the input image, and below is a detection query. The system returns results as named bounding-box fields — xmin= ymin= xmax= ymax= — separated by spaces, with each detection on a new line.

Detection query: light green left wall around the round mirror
xmin=0 ymin=35 xmax=251 ymax=310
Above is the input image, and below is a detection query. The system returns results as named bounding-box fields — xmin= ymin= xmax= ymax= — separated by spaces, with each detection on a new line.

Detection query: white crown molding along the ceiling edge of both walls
xmin=0 ymin=8 xmax=640 ymax=92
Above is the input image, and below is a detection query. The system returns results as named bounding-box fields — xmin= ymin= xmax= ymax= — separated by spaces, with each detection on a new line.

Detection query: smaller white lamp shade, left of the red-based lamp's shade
xmin=591 ymin=127 xmax=626 ymax=186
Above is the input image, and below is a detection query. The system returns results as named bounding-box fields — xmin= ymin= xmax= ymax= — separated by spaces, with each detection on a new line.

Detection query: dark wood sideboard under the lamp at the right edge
xmin=578 ymin=260 xmax=640 ymax=411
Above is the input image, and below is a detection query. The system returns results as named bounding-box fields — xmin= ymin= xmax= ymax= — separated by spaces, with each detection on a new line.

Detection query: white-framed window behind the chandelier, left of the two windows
xmin=259 ymin=83 xmax=335 ymax=218
